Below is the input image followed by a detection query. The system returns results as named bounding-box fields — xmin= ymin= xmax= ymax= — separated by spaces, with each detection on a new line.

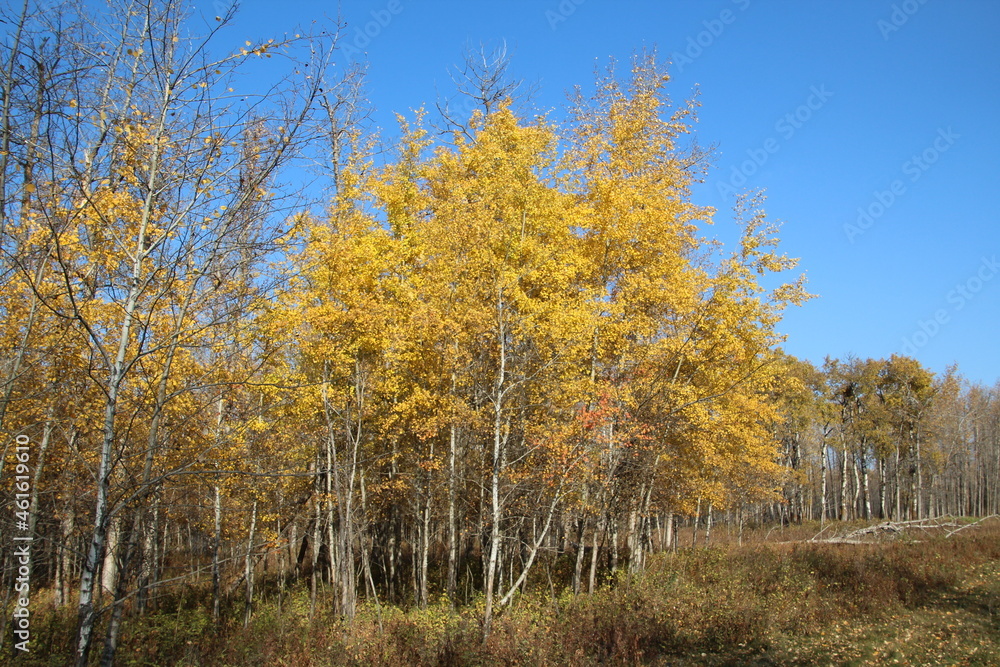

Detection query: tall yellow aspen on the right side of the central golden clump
xmin=567 ymin=54 xmax=805 ymax=559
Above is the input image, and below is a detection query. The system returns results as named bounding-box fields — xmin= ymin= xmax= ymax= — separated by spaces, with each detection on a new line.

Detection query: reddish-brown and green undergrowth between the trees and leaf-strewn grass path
xmin=13 ymin=526 xmax=1000 ymax=667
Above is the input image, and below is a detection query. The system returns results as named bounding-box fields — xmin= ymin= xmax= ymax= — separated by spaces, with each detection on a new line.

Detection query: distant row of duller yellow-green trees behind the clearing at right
xmin=773 ymin=355 xmax=1000 ymax=520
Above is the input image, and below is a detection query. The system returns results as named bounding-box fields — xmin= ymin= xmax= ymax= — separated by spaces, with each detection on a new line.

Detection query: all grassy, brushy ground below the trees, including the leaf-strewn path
xmin=7 ymin=520 xmax=1000 ymax=667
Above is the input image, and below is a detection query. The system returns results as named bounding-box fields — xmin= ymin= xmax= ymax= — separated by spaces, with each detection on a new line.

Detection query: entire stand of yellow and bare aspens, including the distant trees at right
xmin=0 ymin=0 xmax=1000 ymax=665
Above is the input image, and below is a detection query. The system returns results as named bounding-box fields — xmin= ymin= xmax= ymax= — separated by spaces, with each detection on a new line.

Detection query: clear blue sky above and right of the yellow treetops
xmin=215 ymin=0 xmax=1000 ymax=384
